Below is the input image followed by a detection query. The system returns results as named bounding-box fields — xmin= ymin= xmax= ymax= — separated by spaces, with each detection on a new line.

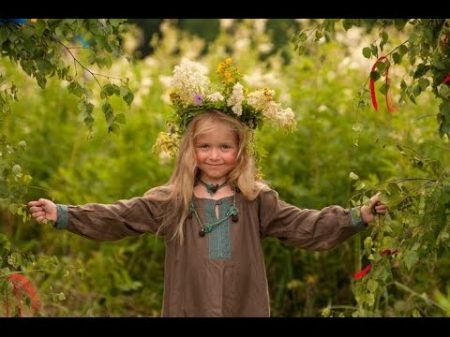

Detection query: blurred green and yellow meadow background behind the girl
xmin=0 ymin=19 xmax=450 ymax=317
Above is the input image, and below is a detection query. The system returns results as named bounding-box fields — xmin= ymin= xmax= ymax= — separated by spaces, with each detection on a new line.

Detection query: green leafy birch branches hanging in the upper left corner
xmin=0 ymin=19 xmax=133 ymax=131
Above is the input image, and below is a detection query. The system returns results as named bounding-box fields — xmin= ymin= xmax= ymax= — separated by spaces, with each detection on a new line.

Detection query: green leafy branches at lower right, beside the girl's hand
xmin=348 ymin=145 xmax=450 ymax=316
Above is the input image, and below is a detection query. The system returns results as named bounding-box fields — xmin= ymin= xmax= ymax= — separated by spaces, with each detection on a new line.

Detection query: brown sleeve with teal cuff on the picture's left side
xmin=56 ymin=197 xmax=165 ymax=241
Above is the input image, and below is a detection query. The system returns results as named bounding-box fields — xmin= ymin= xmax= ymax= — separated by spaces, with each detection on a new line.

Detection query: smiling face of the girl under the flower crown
xmin=194 ymin=122 xmax=239 ymax=183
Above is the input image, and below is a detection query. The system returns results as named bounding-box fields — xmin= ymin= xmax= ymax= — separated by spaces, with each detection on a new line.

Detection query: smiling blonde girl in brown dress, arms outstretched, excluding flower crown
xmin=28 ymin=59 xmax=386 ymax=316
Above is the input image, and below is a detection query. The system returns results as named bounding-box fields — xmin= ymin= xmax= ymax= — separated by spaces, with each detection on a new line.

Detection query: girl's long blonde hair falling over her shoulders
xmin=145 ymin=110 xmax=268 ymax=243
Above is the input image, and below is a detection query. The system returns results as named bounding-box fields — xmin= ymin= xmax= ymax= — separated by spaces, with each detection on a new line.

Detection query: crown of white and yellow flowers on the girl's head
xmin=155 ymin=58 xmax=296 ymax=158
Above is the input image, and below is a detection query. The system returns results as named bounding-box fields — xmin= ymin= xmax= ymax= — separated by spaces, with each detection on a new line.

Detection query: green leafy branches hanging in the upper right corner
xmin=292 ymin=19 xmax=450 ymax=137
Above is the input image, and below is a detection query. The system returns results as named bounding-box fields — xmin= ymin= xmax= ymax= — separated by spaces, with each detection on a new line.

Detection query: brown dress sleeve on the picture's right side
xmin=259 ymin=190 xmax=366 ymax=250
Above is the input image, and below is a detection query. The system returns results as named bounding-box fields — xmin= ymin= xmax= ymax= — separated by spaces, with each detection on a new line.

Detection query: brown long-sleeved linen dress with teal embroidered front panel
xmin=55 ymin=189 xmax=365 ymax=317
